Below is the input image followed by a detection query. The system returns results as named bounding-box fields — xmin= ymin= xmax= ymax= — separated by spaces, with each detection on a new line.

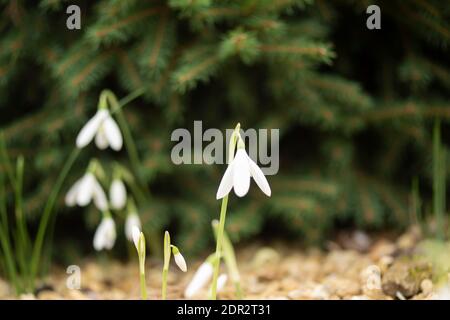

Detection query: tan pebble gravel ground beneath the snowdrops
xmin=0 ymin=231 xmax=448 ymax=300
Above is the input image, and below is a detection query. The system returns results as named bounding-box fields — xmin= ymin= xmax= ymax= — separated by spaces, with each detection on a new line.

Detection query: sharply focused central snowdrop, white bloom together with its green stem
xmin=211 ymin=123 xmax=271 ymax=300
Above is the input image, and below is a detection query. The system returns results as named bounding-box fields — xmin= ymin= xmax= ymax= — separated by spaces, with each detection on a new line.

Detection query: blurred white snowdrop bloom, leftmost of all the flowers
xmin=65 ymin=171 xmax=108 ymax=211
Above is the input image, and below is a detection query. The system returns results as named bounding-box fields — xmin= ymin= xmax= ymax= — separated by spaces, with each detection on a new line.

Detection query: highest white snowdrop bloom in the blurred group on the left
xmin=76 ymin=108 xmax=123 ymax=151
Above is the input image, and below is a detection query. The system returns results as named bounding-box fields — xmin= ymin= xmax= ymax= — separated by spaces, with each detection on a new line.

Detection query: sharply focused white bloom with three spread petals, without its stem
xmin=216 ymin=138 xmax=271 ymax=199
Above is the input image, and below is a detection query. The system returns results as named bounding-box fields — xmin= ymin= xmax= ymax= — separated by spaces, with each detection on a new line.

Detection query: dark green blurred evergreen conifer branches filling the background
xmin=0 ymin=0 xmax=450 ymax=253
